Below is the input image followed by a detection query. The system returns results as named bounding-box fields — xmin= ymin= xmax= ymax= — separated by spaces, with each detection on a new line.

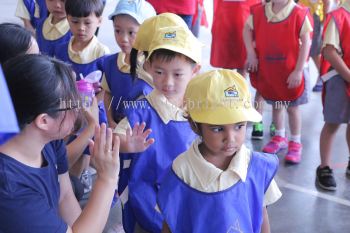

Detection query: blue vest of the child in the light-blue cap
xmin=104 ymin=53 xmax=152 ymax=122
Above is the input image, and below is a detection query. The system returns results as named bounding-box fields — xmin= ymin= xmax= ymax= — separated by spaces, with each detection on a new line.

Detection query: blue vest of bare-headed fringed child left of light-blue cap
xmin=54 ymin=42 xmax=107 ymax=124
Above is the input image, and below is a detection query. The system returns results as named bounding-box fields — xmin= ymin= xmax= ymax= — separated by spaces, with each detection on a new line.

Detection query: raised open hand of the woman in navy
xmin=89 ymin=123 xmax=120 ymax=183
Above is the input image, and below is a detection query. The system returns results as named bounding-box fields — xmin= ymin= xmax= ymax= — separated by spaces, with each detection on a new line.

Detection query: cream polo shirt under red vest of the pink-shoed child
xmin=246 ymin=0 xmax=313 ymax=36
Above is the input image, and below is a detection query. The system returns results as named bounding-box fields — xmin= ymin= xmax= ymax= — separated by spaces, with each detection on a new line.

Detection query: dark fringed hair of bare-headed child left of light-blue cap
xmin=65 ymin=0 xmax=104 ymax=18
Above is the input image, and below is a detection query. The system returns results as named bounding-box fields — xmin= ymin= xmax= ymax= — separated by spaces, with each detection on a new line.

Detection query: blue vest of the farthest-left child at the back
xmin=36 ymin=20 xmax=72 ymax=57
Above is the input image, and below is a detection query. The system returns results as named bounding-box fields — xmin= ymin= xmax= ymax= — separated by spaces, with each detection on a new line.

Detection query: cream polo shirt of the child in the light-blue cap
xmin=101 ymin=52 xmax=153 ymax=93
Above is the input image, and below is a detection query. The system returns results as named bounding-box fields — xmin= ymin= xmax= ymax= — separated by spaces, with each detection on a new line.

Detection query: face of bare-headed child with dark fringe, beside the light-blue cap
xmin=67 ymin=13 xmax=102 ymax=42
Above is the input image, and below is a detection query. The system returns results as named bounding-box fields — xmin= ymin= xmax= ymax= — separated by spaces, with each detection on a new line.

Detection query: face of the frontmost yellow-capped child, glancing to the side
xmin=200 ymin=122 xmax=247 ymax=159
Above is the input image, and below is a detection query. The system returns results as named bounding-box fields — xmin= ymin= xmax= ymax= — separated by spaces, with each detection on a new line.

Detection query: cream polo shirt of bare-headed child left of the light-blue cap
xmin=68 ymin=36 xmax=109 ymax=64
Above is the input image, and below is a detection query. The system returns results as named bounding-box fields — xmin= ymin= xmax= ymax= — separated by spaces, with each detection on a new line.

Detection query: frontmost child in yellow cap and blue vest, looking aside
xmin=157 ymin=70 xmax=281 ymax=233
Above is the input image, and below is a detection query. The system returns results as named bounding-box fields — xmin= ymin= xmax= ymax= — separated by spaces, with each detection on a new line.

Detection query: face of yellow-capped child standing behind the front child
xmin=148 ymin=56 xmax=199 ymax=105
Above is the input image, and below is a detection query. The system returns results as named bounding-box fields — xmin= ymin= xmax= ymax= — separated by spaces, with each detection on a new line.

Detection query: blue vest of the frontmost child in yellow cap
xmin=157 ymin=152 xmax=278 ymax=233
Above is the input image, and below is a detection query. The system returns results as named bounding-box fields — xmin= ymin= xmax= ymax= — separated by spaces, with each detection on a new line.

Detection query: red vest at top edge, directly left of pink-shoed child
xmin=210 ymin=0 xmax=261 ymax=69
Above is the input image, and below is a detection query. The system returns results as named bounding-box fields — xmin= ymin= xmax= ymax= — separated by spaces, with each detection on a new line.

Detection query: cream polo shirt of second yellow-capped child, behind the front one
xmin=114 ymin=89 xmax=187 ymax=135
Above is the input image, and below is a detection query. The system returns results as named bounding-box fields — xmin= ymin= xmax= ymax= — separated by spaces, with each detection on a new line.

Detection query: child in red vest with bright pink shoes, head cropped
xmin=243 ymin=0 xmax=312 ymax=164
